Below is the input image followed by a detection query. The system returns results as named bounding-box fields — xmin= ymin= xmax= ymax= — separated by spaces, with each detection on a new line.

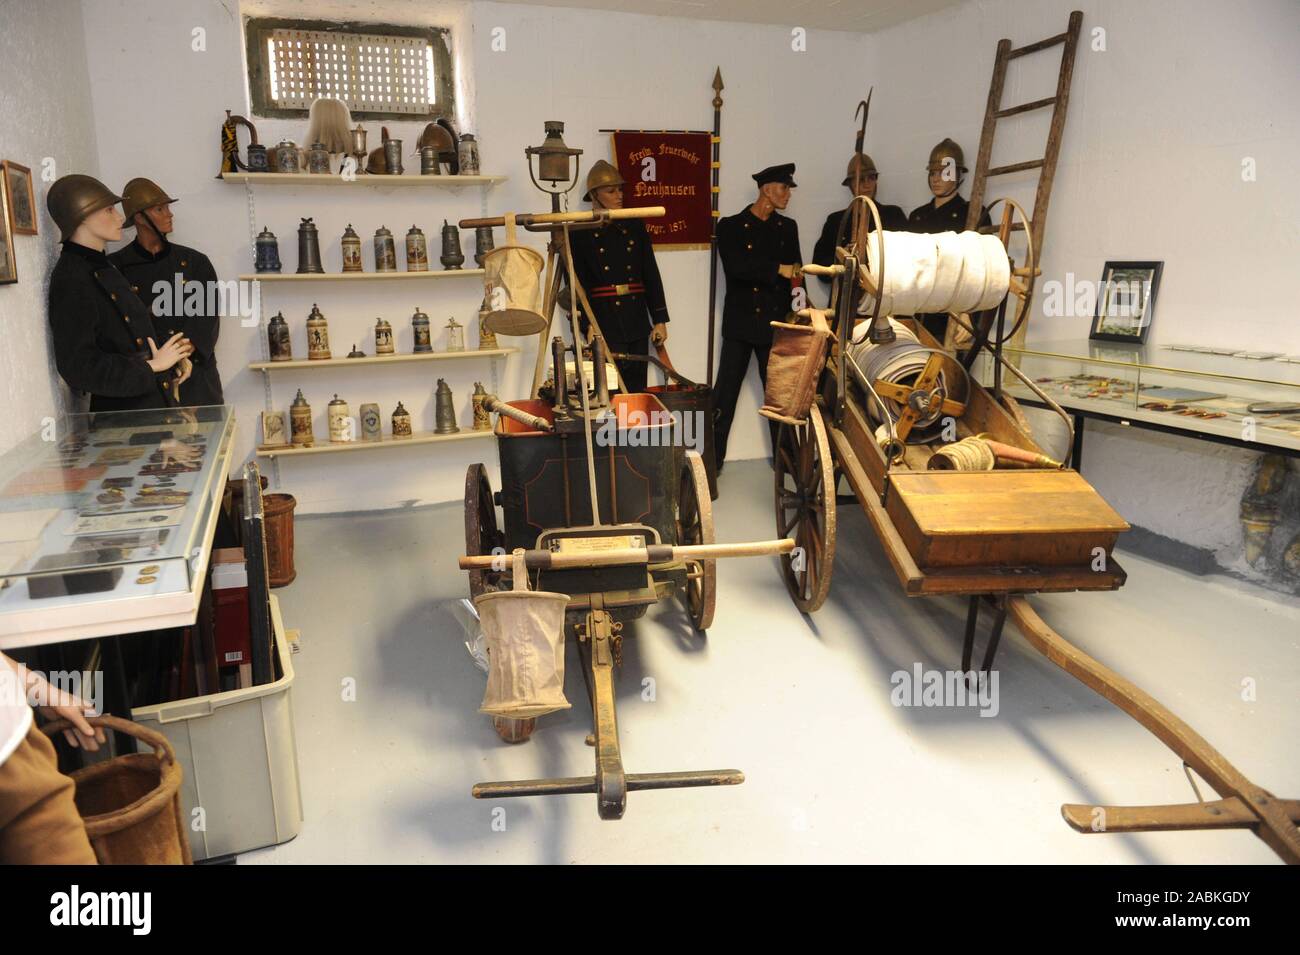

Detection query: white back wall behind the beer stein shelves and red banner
xmin=76 ymin=0 xmax=862 ymax=512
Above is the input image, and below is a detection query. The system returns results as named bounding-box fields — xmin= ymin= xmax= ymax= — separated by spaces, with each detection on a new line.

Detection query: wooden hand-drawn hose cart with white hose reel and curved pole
xmin=763 ymin=128 xmax=1300 ymax=863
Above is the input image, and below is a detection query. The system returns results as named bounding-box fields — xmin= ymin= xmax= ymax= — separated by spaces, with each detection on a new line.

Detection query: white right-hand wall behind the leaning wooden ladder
xmin=863 ymin=0 xmax=1300 ymax=568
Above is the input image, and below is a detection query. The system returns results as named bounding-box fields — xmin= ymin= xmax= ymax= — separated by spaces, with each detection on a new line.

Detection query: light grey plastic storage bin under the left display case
xmin=131 ymin=596 xmax=303 ymax=861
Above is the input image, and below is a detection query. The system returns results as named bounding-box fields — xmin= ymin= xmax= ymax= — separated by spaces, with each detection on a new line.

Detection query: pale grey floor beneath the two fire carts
xmin=239 ymin=461 xmax=1300 ymax=864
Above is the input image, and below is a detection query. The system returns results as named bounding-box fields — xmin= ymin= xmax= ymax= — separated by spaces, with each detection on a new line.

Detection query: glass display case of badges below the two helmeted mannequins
xmin=0 ymin=405 xmax=234 ymax=642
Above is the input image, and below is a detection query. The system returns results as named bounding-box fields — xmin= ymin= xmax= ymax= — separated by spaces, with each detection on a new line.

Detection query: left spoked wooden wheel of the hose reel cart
xmin=775 ymin=404 xmax=835 ymax=613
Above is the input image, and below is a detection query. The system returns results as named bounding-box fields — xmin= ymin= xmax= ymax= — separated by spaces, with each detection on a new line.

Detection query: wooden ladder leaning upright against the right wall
xmin=966 ymin=10 xmax=1083 ymax=343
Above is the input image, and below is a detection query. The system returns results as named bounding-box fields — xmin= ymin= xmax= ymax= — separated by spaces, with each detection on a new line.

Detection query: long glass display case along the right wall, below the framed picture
xmin=979 ymin=340 xmax=1300 ymax=455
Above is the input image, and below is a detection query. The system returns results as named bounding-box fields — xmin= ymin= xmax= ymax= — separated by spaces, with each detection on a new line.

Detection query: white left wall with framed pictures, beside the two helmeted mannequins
xmin=0 ymin=0 xmax=98 ymax=453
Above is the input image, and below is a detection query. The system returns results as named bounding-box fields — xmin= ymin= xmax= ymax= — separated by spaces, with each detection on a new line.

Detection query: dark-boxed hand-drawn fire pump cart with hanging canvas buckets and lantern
xmin=460 ymin=123 xmax=793 ymax=819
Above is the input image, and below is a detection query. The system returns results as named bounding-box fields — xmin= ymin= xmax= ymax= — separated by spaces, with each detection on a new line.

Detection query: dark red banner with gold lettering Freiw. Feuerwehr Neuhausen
xmin=614 ymin=131 xmax=712 ymax=249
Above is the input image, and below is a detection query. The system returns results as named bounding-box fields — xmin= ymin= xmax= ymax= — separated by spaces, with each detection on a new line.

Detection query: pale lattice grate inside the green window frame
xmin=267 ymin=29 xmax=438 ymax=116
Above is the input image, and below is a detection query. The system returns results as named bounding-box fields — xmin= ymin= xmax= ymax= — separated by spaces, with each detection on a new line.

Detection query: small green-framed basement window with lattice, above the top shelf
xmin=244 ymin=18 xmax=455 ymax=120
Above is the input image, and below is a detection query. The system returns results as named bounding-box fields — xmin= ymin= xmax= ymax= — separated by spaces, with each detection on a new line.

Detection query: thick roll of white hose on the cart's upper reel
xmin=858 ymin=233 xmax=1011 ymax=314
